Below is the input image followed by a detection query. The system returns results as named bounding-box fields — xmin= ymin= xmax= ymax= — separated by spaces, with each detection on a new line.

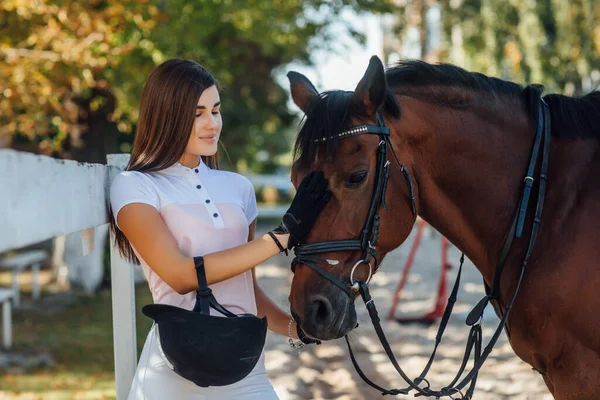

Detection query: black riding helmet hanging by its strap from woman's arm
xmin=142 ymin=257 xmax=267 ymax=387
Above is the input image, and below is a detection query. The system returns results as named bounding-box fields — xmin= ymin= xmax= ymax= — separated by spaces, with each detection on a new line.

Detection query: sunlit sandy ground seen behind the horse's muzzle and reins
xmin=257 ymin=226 xmax=552 ymax=400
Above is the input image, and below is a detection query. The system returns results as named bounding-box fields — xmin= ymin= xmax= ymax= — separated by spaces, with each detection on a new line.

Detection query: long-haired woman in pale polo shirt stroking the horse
xmin=111 ymin=60 xmax=331 ymax=400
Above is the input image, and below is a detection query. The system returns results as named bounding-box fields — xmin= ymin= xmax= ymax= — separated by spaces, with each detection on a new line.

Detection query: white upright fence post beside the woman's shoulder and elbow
xmin=107 ymin=154 xmax=137 ymax=400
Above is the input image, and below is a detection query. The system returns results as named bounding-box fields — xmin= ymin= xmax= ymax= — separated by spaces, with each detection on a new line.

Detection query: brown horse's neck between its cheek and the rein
xmin=406 ymin=102 xmax=534 ymax=283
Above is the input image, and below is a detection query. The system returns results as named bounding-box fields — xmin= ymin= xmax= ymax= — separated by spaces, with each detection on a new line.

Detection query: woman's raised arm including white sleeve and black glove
xmin=111 ymin=171 xmax=331 ymax=294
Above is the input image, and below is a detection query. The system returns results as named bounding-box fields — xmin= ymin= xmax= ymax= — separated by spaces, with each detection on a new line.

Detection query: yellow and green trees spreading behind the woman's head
xmin=0 ymin=0 xmax=390 ymax=169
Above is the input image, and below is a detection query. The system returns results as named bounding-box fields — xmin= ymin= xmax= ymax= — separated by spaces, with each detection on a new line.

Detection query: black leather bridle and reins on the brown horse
xmin=292 ymin=89 xmax=551 ymax=399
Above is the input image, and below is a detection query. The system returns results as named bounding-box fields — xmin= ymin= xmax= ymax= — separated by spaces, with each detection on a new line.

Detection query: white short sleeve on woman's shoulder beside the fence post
xmin=110 ymin=171 xmax=159 ymax=226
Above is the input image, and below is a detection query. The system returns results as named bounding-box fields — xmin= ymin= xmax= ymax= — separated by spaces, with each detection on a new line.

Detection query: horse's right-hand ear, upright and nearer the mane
xmin=352 ymin=56 xmax=387 ymax=115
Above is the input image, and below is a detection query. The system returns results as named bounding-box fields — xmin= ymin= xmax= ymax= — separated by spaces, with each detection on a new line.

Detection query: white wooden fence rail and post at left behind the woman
xmin=0 ymin=149 xmax=285 ymax=400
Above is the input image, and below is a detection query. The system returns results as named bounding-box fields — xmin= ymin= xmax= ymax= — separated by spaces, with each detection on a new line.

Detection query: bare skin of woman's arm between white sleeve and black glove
xmin=117 ymin=203 xmax=289 ymax=294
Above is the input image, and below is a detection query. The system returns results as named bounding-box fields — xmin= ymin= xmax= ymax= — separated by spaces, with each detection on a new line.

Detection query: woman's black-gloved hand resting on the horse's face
xmin=272 ymin=171 xmax=332 ymax=249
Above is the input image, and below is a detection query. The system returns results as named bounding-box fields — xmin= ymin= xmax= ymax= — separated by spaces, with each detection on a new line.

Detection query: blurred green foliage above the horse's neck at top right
xmin=439 ymin=0 xmax=600 ymax=94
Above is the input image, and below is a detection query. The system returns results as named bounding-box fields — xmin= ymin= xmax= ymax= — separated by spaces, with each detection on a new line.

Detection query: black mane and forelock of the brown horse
xmin=294 ymin=60 xmax=600 ymax=165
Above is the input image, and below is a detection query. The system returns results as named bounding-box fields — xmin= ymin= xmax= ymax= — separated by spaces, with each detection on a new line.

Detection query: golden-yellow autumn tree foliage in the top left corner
xmin=0 ymin=0 xmax=157 ymax=159
